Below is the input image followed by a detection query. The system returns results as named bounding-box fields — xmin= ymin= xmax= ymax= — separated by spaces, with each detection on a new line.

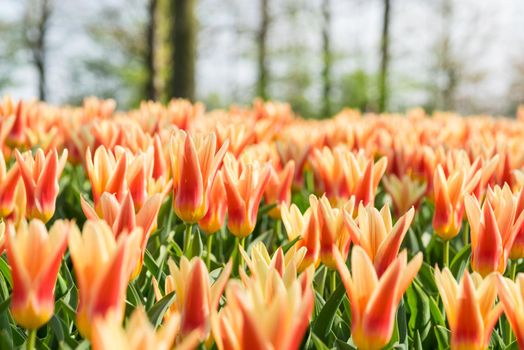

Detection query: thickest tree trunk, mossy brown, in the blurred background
xmin=168 ymin=0 xmax=197 ymax=101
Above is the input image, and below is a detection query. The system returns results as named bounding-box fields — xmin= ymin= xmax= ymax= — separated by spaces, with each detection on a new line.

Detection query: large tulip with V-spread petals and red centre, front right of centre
xmin=334 ymin=246 xmax=422 ymax=349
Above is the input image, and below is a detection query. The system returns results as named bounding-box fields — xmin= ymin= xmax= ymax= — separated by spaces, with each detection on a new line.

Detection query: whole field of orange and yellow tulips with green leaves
xmin=0 ymin=97 xmax=524 ymax=350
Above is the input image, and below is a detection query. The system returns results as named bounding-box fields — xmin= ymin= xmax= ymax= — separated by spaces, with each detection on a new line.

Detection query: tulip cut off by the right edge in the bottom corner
xmin=497 ymin=273 xmax=524 ymax=349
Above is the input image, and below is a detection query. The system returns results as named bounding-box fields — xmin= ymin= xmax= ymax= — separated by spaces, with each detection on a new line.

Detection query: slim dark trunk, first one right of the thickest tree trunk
xmin=257 ymin=0 xmax=269 ymax=99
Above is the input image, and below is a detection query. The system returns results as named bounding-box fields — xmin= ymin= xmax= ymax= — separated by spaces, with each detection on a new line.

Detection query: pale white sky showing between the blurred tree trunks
xmin=0 ymin=0 xmax=524 ymax=113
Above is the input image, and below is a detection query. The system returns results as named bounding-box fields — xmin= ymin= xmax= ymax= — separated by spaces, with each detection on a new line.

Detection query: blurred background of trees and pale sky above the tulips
xmin=0 ymin=0 xmax=524 ymax=118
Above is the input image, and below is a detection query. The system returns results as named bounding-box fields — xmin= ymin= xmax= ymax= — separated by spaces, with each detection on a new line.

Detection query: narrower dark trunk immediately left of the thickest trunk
xmin=144 ymin=0 xmax=157 ymax=100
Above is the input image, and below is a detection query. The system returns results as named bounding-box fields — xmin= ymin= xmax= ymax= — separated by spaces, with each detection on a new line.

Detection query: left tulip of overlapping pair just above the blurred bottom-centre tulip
xmin=281 ymin=200 xmax=320 ymax=271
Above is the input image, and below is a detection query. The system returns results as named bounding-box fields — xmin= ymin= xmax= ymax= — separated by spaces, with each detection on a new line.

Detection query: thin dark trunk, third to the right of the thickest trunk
xmin=378 ymin=0 xmax=391 ymax=112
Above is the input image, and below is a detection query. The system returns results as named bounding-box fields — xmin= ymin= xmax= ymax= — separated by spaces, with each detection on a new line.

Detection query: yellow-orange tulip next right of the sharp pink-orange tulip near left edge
xmin=86 ymin=146 xmax=127 ymax=208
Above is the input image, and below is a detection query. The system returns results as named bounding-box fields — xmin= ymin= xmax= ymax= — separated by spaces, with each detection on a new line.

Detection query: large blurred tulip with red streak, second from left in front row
xmin=69 ymin=220 xmax=142 ymax=339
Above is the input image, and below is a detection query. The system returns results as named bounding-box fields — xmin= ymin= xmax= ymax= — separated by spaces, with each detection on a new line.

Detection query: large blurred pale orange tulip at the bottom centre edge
xmin=211 ymin=259 xmax=314 ymax=350
